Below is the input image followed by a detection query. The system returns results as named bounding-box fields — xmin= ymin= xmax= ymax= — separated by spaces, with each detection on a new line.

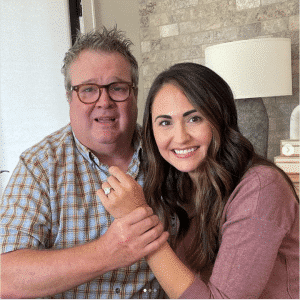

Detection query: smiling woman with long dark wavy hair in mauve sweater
xmin=98 ymin=63 xmax=299 ymax=299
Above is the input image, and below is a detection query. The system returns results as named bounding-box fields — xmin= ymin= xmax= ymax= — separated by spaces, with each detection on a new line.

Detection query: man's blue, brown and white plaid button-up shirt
xmin=0 ymin=125 xmax=166 ymax=299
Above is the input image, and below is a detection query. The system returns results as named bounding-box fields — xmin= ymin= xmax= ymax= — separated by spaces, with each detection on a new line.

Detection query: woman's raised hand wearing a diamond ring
xmin=97 ymin=166 xmax=148 ymax=218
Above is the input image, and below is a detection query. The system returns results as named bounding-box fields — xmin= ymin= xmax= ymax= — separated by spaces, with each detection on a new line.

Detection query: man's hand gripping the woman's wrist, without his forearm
xmin=99 ymin=207 xmax=169 ymax=269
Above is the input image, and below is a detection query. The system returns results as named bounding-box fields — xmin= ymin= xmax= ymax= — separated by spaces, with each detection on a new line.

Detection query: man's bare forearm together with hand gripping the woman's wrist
xmin=1 ymin=207 xmax=169 ymax=299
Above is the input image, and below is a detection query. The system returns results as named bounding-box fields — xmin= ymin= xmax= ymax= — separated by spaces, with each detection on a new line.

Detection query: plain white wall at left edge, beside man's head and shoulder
xmin=0 ymin=0 xmax=71 ymax=196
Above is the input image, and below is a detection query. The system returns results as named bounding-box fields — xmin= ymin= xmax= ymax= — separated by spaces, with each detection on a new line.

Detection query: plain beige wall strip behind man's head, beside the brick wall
xmin=94 ymin=0 xmax=145 ymax=124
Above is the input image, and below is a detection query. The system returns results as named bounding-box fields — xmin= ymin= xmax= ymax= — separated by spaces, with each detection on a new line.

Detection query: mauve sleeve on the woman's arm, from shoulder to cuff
xmin=180 ymin=168 xmax=296 ymax=299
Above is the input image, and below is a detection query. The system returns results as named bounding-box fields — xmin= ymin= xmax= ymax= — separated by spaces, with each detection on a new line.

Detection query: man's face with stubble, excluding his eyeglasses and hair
xmin=70 ymin=50 xmax=137 ymax=152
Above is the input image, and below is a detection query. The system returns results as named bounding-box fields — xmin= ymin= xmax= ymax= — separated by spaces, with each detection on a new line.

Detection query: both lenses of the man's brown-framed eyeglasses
xmin=78 ymin=82 xmax=130 ymax=103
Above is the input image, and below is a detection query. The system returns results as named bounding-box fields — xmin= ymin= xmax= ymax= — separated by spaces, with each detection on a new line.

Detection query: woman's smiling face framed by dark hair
xmin=152 ymin=84 xmax=212 ymax=176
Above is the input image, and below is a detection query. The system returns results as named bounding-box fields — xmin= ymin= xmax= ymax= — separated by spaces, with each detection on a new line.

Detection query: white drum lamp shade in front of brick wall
xmin=205 ymin=38 xmax=292 ymax=99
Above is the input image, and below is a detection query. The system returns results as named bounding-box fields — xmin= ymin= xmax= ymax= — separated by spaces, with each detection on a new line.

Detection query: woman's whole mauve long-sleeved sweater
xmin=176 ymin=166 xmax=299 ymax=299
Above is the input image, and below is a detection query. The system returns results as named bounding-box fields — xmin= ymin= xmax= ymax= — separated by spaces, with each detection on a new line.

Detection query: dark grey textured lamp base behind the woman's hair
xmin=235 ymin=98 xmax=269 ymax=158
